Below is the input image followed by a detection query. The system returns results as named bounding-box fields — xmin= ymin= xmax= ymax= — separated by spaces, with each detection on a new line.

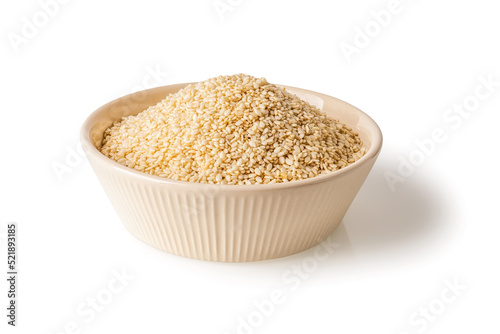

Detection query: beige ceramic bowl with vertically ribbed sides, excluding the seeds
xmin=81 ymin=84 xmax=382 ymax=262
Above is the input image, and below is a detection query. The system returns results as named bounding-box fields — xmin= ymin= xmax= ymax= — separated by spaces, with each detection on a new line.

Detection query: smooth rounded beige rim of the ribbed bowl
xmin=80 ymin=82 xmax=383 ymax=192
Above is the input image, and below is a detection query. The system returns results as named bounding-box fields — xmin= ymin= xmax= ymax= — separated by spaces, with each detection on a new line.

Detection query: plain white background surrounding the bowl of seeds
xmin=0 ymin=0 xmax=500 ymax=334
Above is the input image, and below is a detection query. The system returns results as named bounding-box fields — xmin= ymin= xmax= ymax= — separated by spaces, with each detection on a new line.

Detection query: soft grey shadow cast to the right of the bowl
xmin=340 ymin=160 xmax=444 ymax=252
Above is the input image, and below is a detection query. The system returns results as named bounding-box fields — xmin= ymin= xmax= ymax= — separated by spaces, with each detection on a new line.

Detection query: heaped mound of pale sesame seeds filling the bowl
xmin=100 ymin=74 xmax=365 ymax=185
